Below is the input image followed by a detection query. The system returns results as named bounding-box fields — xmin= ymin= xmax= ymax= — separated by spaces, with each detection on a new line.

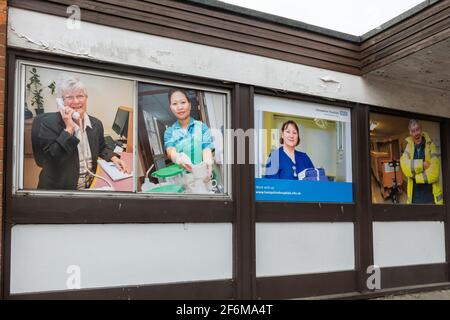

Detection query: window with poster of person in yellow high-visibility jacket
xmin=369 ymin=113 xmax=443 ymax=204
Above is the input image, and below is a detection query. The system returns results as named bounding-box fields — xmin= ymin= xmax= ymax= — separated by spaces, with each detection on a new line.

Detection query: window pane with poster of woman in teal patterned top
xmin=138 ymin=82 xmax=228 ymax=195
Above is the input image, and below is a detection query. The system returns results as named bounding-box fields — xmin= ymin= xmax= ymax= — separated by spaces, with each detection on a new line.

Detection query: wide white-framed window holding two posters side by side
xmin=13 ymin=61 xmax=230 ymax=197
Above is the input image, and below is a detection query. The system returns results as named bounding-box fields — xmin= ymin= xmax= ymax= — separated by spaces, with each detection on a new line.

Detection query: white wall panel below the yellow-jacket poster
xmin=373 ymin=221 xmax=445 ymax=267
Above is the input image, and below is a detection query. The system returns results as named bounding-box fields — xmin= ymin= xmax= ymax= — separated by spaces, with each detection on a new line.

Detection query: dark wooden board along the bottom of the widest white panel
xmin=8 ymin=280 xmax=233 ymax=300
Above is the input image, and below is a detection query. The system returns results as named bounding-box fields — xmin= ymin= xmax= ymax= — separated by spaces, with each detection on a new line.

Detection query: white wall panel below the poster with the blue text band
xmin=256 ymin=222 xmax=355 ymax=277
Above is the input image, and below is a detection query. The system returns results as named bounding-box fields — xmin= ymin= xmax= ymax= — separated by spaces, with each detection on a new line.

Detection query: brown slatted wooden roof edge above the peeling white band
xmin=9 ymin=0 xmax=450 ymax=75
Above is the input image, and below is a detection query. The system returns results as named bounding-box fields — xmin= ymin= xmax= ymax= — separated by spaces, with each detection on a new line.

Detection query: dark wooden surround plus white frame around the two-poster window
xmin=5 ymin=49 xmax=236 ymax=224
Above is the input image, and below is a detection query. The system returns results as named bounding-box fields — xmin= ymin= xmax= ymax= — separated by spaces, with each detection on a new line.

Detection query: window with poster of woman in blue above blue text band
xmin=255 ymin=96 xmax=353 ymax=202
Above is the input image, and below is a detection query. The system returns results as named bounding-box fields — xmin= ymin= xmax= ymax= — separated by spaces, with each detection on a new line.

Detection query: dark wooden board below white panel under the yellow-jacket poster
xmin=380 ymin=263 xmax=449 ymax=289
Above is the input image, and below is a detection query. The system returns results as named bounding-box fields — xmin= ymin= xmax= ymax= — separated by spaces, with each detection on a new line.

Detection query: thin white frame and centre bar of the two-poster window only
xmin=12 ymin=59 xmax=232 ymax=200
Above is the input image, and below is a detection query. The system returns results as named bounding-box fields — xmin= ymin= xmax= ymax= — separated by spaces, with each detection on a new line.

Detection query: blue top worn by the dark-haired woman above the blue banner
xmin=264 ymin=147 xmax=314 ymax=180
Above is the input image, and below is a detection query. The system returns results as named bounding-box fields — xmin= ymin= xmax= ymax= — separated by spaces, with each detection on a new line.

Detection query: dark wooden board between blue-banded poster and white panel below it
xmin=256 ymin=202 xmax=356 ymax=222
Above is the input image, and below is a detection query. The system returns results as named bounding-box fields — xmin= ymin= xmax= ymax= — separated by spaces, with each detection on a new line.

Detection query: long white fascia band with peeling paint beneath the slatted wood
xmin=7 ymin=8 xmax=450 ymax=117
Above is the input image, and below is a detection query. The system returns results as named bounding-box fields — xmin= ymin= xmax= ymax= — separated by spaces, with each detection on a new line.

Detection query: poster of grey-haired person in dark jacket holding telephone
xmin=18 ymin=64 xmax=135 ymax=192
